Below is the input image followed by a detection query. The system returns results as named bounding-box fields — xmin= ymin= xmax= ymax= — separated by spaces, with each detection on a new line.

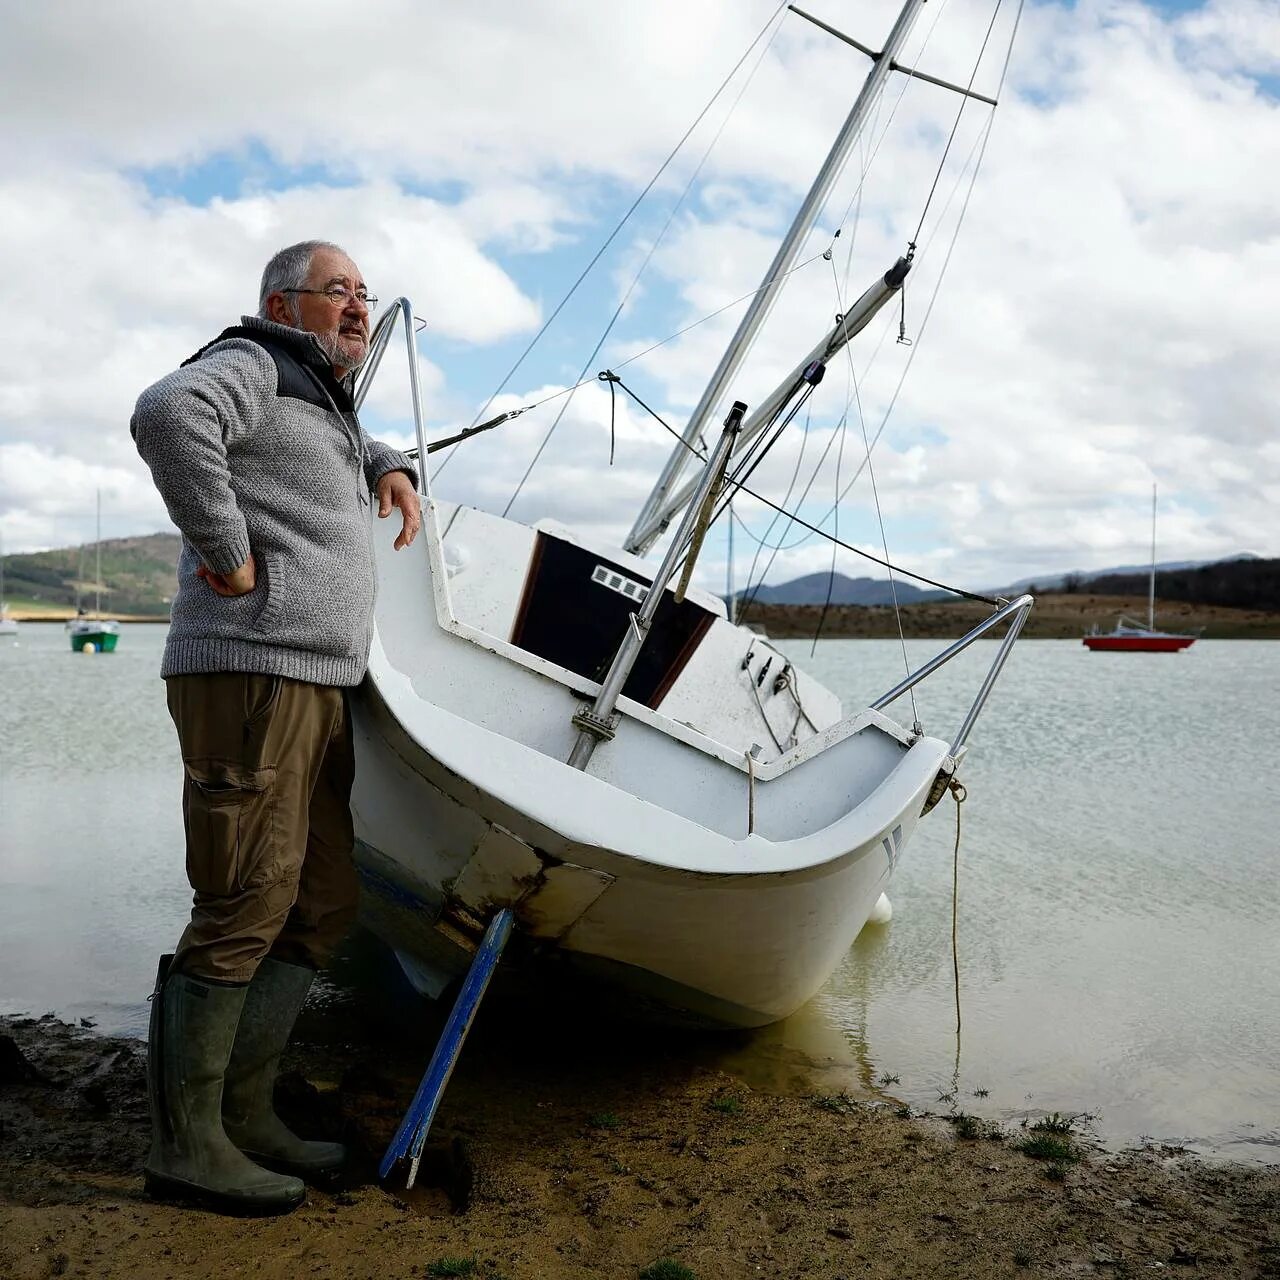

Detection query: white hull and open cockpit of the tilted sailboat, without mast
xmin=353 ymin=504 xmax=955 ymax=1027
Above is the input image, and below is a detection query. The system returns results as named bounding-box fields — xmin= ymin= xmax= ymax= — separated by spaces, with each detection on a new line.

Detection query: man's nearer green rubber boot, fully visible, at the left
xmin=142 ymin=956 xmax=306 ymax=1217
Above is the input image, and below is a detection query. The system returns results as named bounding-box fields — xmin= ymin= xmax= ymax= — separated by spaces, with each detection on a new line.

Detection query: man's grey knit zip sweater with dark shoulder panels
xmin=131 ymin=316 xmax=417 ymax=685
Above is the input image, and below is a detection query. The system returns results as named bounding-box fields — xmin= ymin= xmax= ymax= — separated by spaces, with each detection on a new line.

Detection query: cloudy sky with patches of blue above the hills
xmin=0 ymin=0 xmax=1280 ymax=586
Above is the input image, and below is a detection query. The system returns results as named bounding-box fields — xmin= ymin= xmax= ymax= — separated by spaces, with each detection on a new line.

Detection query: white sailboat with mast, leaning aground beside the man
xmin=353 ymin=0 xmax=1032 ymax=1027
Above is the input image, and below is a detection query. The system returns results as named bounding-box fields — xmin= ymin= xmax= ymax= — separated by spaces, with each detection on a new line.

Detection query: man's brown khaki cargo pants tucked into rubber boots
xmin=165 ymin=672 xmax=357 ymax=983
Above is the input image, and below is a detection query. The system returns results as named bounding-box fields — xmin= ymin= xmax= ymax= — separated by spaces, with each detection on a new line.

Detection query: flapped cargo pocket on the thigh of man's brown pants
xmin=183 ymin=758 xmax=280 ymax=897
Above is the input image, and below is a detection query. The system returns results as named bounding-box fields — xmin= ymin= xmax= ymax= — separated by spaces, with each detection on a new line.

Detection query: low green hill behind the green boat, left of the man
xmin=4 ymin=534 xmax=182 ymax=617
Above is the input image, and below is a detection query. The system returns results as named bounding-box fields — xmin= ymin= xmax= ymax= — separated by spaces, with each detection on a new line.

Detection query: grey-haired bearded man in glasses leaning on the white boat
xmin=132 ymin=241 xmax=421 ymax=1213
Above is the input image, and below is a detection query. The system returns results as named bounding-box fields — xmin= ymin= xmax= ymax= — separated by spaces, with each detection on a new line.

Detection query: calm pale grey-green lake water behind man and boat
xmin=0 ymin=626 xmax=1280 ymax=1162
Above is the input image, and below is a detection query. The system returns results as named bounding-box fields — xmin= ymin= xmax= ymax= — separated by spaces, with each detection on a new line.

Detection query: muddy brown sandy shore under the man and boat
xmin=0 ymin=972 xmax=1280 ymax=1280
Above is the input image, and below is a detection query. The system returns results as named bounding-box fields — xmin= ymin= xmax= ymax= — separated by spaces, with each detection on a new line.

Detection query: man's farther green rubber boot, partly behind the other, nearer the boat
xmin=223 ymin=959 xmax=347 ymax=1185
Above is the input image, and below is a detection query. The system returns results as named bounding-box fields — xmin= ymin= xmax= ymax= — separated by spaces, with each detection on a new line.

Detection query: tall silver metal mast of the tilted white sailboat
xmin=623 ymin=0 xmax=924 ymax=550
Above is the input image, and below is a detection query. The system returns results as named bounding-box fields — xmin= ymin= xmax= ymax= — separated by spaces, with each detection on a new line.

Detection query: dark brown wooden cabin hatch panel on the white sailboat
xmin=511 ymin=530 xmax=716 ymax=709
